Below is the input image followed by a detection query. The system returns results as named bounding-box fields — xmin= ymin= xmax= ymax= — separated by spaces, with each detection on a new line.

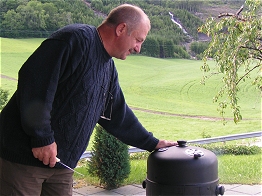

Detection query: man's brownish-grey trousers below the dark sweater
xmin=0 ymin=158 xmax=73 ymax=196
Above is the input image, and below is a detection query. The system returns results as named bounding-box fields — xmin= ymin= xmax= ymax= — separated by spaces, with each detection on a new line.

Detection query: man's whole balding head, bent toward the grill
xmin=97 ymin=4 xmax=150 ymax=60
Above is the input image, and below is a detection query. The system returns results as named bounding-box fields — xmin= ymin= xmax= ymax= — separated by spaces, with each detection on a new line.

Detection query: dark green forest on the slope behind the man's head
xmin=0 ymin=0 xmax=243 ymax=58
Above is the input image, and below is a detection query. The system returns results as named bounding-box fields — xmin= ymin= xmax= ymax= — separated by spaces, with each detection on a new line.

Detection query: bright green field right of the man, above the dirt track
xmin=116 ymin=56 xmax=260 ymax=119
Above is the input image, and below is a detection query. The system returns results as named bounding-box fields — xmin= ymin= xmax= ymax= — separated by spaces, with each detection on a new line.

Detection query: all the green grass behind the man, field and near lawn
xmin=1 ymin=38 xmax=261 ymax=184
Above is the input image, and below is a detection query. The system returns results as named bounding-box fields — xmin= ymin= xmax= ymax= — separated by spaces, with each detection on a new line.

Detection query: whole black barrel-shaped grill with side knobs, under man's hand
xmin=143 ymin=141 xmax=225 ymax=196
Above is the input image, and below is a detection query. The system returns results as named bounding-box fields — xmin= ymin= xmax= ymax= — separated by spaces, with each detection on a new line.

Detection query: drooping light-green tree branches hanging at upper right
xmin=199 ymin=0 xmax=262 ymax=123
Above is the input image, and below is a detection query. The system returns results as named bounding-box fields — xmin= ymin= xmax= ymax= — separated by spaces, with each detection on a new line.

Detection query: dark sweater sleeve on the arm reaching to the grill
xmin=99 ymin=70 xmax=159 ymax=152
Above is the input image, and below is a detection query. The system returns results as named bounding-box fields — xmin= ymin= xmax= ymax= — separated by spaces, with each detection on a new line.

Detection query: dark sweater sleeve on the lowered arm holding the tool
xmin=17 ymin=39 xmax=82 ymax=147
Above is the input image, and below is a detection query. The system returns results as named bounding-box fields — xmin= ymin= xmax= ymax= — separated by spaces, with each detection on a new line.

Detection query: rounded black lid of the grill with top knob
xmin=147 ymin=141 xmax=218 ymax=185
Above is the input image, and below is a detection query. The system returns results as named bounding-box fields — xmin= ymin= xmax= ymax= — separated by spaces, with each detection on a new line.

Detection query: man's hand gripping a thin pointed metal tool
xmin=32 ymin=142 xmax=57 ymax=167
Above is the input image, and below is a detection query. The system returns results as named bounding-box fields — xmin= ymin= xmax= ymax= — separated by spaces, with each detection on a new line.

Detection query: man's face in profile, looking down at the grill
xmin=115 ymin=24 xmax=148 ymax=60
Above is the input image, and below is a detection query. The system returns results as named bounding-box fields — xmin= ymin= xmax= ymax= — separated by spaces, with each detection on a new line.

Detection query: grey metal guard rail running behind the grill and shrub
xmin=80 ymin=131 xmax=262 ymax=159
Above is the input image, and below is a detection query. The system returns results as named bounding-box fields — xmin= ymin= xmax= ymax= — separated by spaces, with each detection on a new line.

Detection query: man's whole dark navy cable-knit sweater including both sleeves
xmin=0 ymin=24 xmax=158 ymax=168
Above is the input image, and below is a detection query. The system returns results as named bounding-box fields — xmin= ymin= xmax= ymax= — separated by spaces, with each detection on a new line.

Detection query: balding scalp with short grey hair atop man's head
xmin=103 ymin=4 xmax=151 ymax=34
